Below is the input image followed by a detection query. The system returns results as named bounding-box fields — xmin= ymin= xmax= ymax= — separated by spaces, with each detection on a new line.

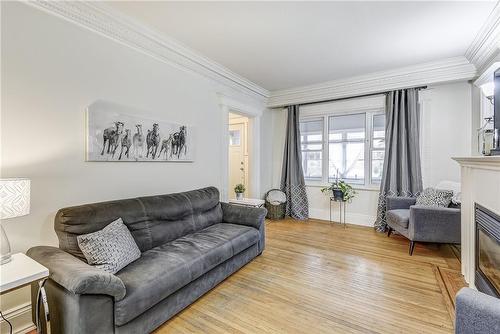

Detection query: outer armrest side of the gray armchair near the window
xmin=408 ymin=205 xmax=461 ymax=243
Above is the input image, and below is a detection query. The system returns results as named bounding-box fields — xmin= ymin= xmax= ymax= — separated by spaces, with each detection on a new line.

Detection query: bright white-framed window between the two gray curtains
xmin=300 ymin=110 xmax=385 ymax=185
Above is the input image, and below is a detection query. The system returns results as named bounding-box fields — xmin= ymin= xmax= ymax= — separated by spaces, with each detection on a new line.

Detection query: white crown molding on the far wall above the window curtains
xmin=268 ymin=57 xmax=476 ymax=108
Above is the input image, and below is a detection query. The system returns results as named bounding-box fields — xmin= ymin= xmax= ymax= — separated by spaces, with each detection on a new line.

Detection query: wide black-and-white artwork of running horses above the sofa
xmin=86 ymin=101 xmax=194 ymax=162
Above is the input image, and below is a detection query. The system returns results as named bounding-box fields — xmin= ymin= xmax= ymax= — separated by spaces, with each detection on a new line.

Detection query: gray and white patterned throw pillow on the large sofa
xmin=76 ymin=218 xmax=141 ymax=274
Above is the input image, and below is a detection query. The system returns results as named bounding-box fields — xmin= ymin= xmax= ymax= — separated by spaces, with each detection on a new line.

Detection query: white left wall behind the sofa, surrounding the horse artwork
xmin=0 ymin=2 xmax=264 ymax=332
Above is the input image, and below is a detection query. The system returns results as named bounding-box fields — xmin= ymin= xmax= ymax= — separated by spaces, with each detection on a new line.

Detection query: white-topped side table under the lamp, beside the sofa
xmin=0 ymin=253 xmax=50 ymax=333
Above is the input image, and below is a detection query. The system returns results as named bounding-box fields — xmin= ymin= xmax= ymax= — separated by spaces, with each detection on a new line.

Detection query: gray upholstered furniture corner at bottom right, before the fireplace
xmin=455 ymin=288 xmax=500 ymax=334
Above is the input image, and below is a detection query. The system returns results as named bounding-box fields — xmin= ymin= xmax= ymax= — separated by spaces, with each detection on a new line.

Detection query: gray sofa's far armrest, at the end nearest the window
xmin=221 ymin=203 xmax=267 ymax=253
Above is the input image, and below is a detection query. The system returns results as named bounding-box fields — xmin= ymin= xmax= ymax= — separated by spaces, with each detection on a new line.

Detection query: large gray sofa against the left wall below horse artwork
xmin=27 ymin=187 xmax=266 ymax=334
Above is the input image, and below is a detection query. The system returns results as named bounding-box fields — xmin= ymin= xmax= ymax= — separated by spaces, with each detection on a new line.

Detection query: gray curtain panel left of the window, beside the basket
xmin=281 ymin=105 xmax=309 ymax=220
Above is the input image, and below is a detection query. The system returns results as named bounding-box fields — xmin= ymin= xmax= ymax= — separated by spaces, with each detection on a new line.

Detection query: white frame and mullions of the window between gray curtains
xmin=299 ymin=108 xmax=385 ymax=189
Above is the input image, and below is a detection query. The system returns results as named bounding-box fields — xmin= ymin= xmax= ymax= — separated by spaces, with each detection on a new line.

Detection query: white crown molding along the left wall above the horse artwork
xmin=24 ymin=0 xmax=269 ymax=98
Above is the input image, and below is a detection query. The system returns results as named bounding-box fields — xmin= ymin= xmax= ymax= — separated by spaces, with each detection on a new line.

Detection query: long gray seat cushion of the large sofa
xmin=115 ymin=223 xmax=259 ymax=326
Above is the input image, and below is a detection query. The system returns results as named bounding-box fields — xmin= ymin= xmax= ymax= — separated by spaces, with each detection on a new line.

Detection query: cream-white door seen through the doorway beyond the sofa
xmin=228 ymin=123 xmax=248 ymax=198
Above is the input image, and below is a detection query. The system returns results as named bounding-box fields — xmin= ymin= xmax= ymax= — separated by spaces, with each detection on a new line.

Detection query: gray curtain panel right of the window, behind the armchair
xmin=375 ymin=88 xmax=422 ymax=232
